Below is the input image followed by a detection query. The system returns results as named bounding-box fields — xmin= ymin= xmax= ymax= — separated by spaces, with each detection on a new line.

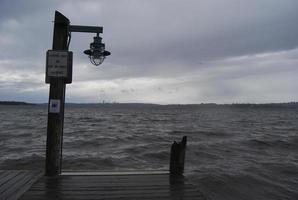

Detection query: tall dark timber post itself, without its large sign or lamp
xmin=45 ymin=11 xmax=69 ymax=176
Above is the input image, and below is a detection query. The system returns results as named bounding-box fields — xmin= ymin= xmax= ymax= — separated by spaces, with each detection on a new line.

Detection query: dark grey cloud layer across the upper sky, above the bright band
xmin=1 ymin=0 xmax=298 ymax=70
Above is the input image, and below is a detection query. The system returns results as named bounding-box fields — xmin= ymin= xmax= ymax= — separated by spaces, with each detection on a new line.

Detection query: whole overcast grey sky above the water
xmin=0 ymin=0 xmax=298 ymax=104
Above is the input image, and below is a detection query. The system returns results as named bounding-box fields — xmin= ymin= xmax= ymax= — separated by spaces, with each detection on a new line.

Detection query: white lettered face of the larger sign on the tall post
xmin=47 ymin=51 xmax=68 ymax=77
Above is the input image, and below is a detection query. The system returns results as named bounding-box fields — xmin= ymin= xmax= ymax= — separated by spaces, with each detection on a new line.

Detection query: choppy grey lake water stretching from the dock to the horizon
xmin=0 ymin=104 xmax=298 ymax=200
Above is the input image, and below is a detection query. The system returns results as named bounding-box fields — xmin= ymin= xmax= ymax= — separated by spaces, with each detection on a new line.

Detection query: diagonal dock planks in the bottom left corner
xmin=0 ymin=170 xmax=42 ymax=200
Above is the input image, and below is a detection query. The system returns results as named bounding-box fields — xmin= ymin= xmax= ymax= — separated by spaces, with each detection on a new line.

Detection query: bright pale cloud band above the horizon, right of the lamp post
xmin=70 ymin=49 xmax=298 ymax=104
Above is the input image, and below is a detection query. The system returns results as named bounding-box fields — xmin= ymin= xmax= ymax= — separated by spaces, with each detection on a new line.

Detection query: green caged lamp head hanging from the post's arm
xmin=84 ymin=33 xmax=111 ymax=66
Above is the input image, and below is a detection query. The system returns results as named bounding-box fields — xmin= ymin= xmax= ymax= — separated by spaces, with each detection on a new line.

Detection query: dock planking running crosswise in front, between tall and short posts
xmin=21 ymin=174 xmax=205 ymax=200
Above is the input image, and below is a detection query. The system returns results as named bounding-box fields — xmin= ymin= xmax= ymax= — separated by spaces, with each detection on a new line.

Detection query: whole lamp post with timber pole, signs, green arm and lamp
xmin=45 ymin=11 xmax=110 ymax=176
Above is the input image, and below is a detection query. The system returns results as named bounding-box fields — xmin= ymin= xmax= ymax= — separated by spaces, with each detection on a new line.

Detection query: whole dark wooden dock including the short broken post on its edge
xmin=0 ymin=136 xmax=205 ymax=200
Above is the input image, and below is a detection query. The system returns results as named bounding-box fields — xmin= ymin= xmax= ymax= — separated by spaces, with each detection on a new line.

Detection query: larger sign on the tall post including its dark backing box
xmin=46 ymin=50 xmax=72 ymax=83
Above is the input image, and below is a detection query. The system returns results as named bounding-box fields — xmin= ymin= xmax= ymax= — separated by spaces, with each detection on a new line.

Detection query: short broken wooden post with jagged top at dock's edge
xmin=170 ymin=136 xmax=187 ymax=175
